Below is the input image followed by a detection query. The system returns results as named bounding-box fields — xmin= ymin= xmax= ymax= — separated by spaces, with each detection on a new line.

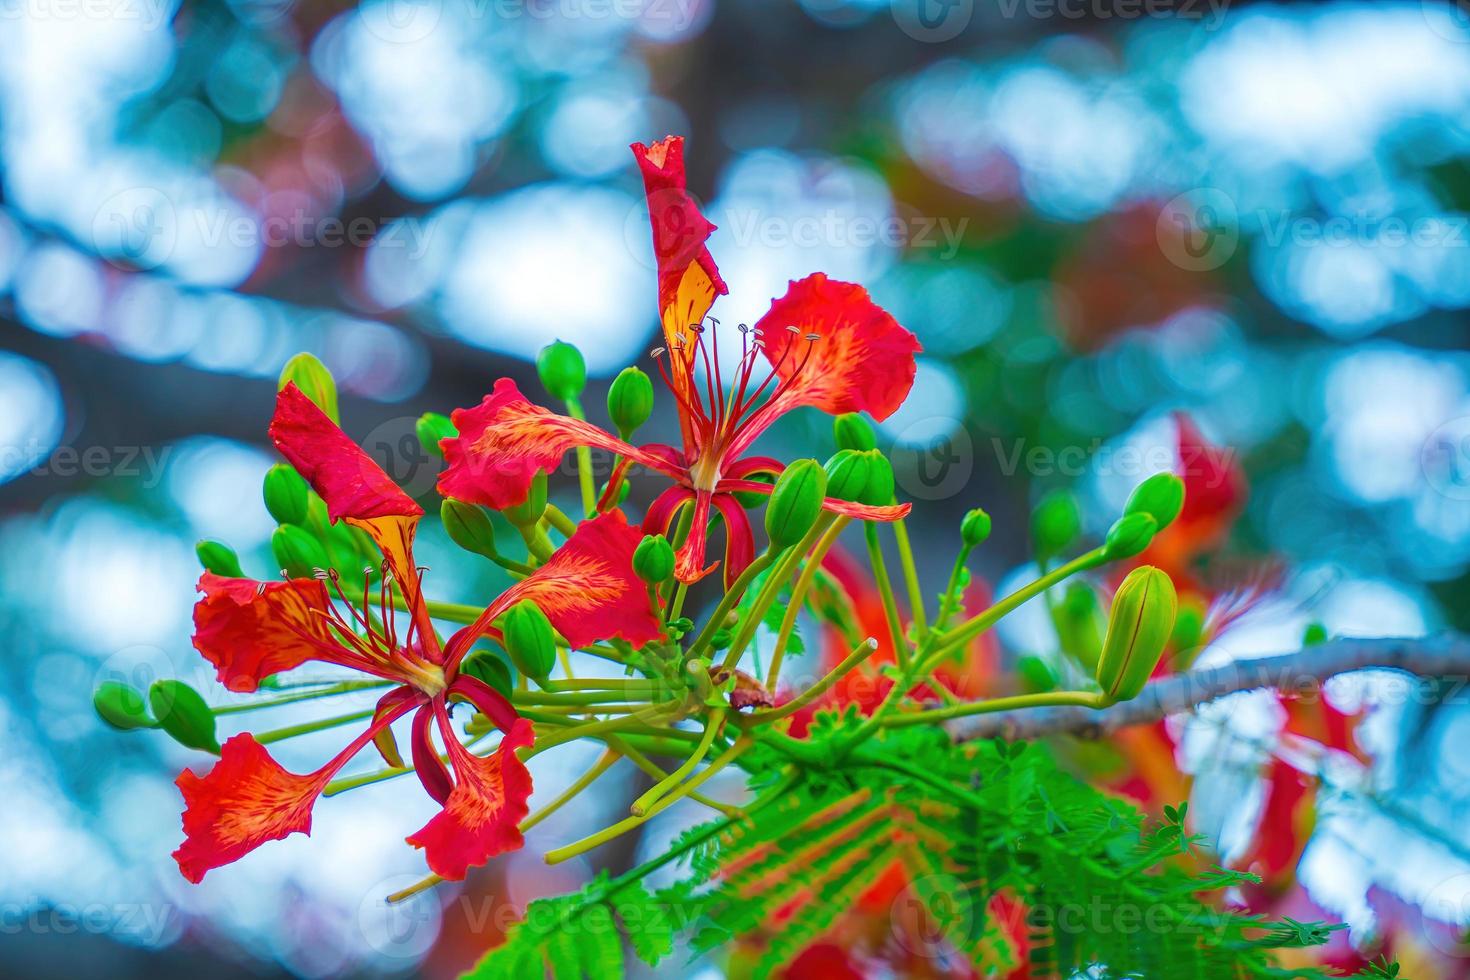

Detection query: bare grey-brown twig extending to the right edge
xmin=948 ymin=633 xmax=1470 ymax=741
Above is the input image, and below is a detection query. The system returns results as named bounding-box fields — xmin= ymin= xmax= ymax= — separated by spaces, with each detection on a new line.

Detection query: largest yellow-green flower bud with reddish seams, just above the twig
xmin=1097 ymin=564 xmax=1179 ymax=702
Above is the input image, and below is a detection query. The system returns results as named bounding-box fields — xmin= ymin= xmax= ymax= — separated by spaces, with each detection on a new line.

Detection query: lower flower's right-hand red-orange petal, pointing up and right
xmin=445 ymin=510 xmax=663 ymax=666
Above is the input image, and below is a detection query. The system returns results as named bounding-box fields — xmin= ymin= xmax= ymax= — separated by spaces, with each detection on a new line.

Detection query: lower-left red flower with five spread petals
xmin=173 ymin=385 xmax=659 ymax=882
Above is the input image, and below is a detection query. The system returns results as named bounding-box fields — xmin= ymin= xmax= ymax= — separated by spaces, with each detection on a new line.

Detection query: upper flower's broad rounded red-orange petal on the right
xmin=731 ymin=272 xmax=923 ymax=455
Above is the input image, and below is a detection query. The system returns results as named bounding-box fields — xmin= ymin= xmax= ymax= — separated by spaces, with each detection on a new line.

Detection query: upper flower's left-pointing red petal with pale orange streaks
xmin=440 ymin=378 xmax=676 ymax=510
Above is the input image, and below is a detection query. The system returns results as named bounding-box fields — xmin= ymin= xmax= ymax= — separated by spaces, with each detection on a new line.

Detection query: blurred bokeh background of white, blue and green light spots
xmin=0 ymin=0 xmax=1470 ymax=977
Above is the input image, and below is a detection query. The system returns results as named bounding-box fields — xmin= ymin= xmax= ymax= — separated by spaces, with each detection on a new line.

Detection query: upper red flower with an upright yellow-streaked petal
xmin=440 ymin=137 xmax=920 ymax=582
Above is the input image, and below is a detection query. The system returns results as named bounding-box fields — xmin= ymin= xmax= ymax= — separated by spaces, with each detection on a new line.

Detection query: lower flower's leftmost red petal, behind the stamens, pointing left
xmin=194 ymin=572 xmax=351 ymax=693
